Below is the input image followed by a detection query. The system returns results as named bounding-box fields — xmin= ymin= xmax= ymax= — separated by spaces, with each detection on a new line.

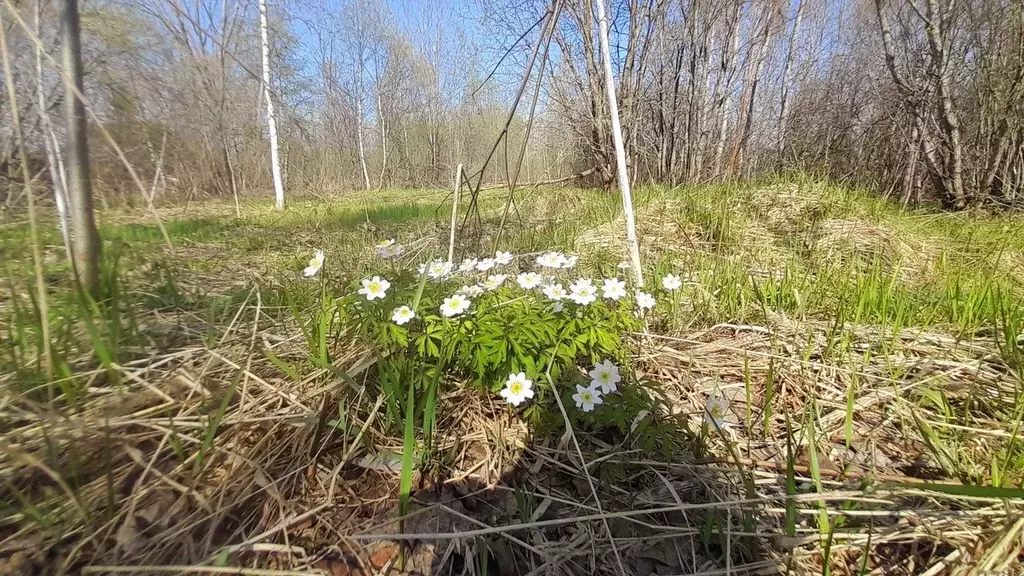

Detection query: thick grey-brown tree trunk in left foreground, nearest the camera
xmin=60 ymin=0 xmax=100 ymax=298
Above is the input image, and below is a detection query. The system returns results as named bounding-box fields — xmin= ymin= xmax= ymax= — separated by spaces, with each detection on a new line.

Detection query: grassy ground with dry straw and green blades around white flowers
xmin=0 ymin=180 xmax=1024 ymax=576
